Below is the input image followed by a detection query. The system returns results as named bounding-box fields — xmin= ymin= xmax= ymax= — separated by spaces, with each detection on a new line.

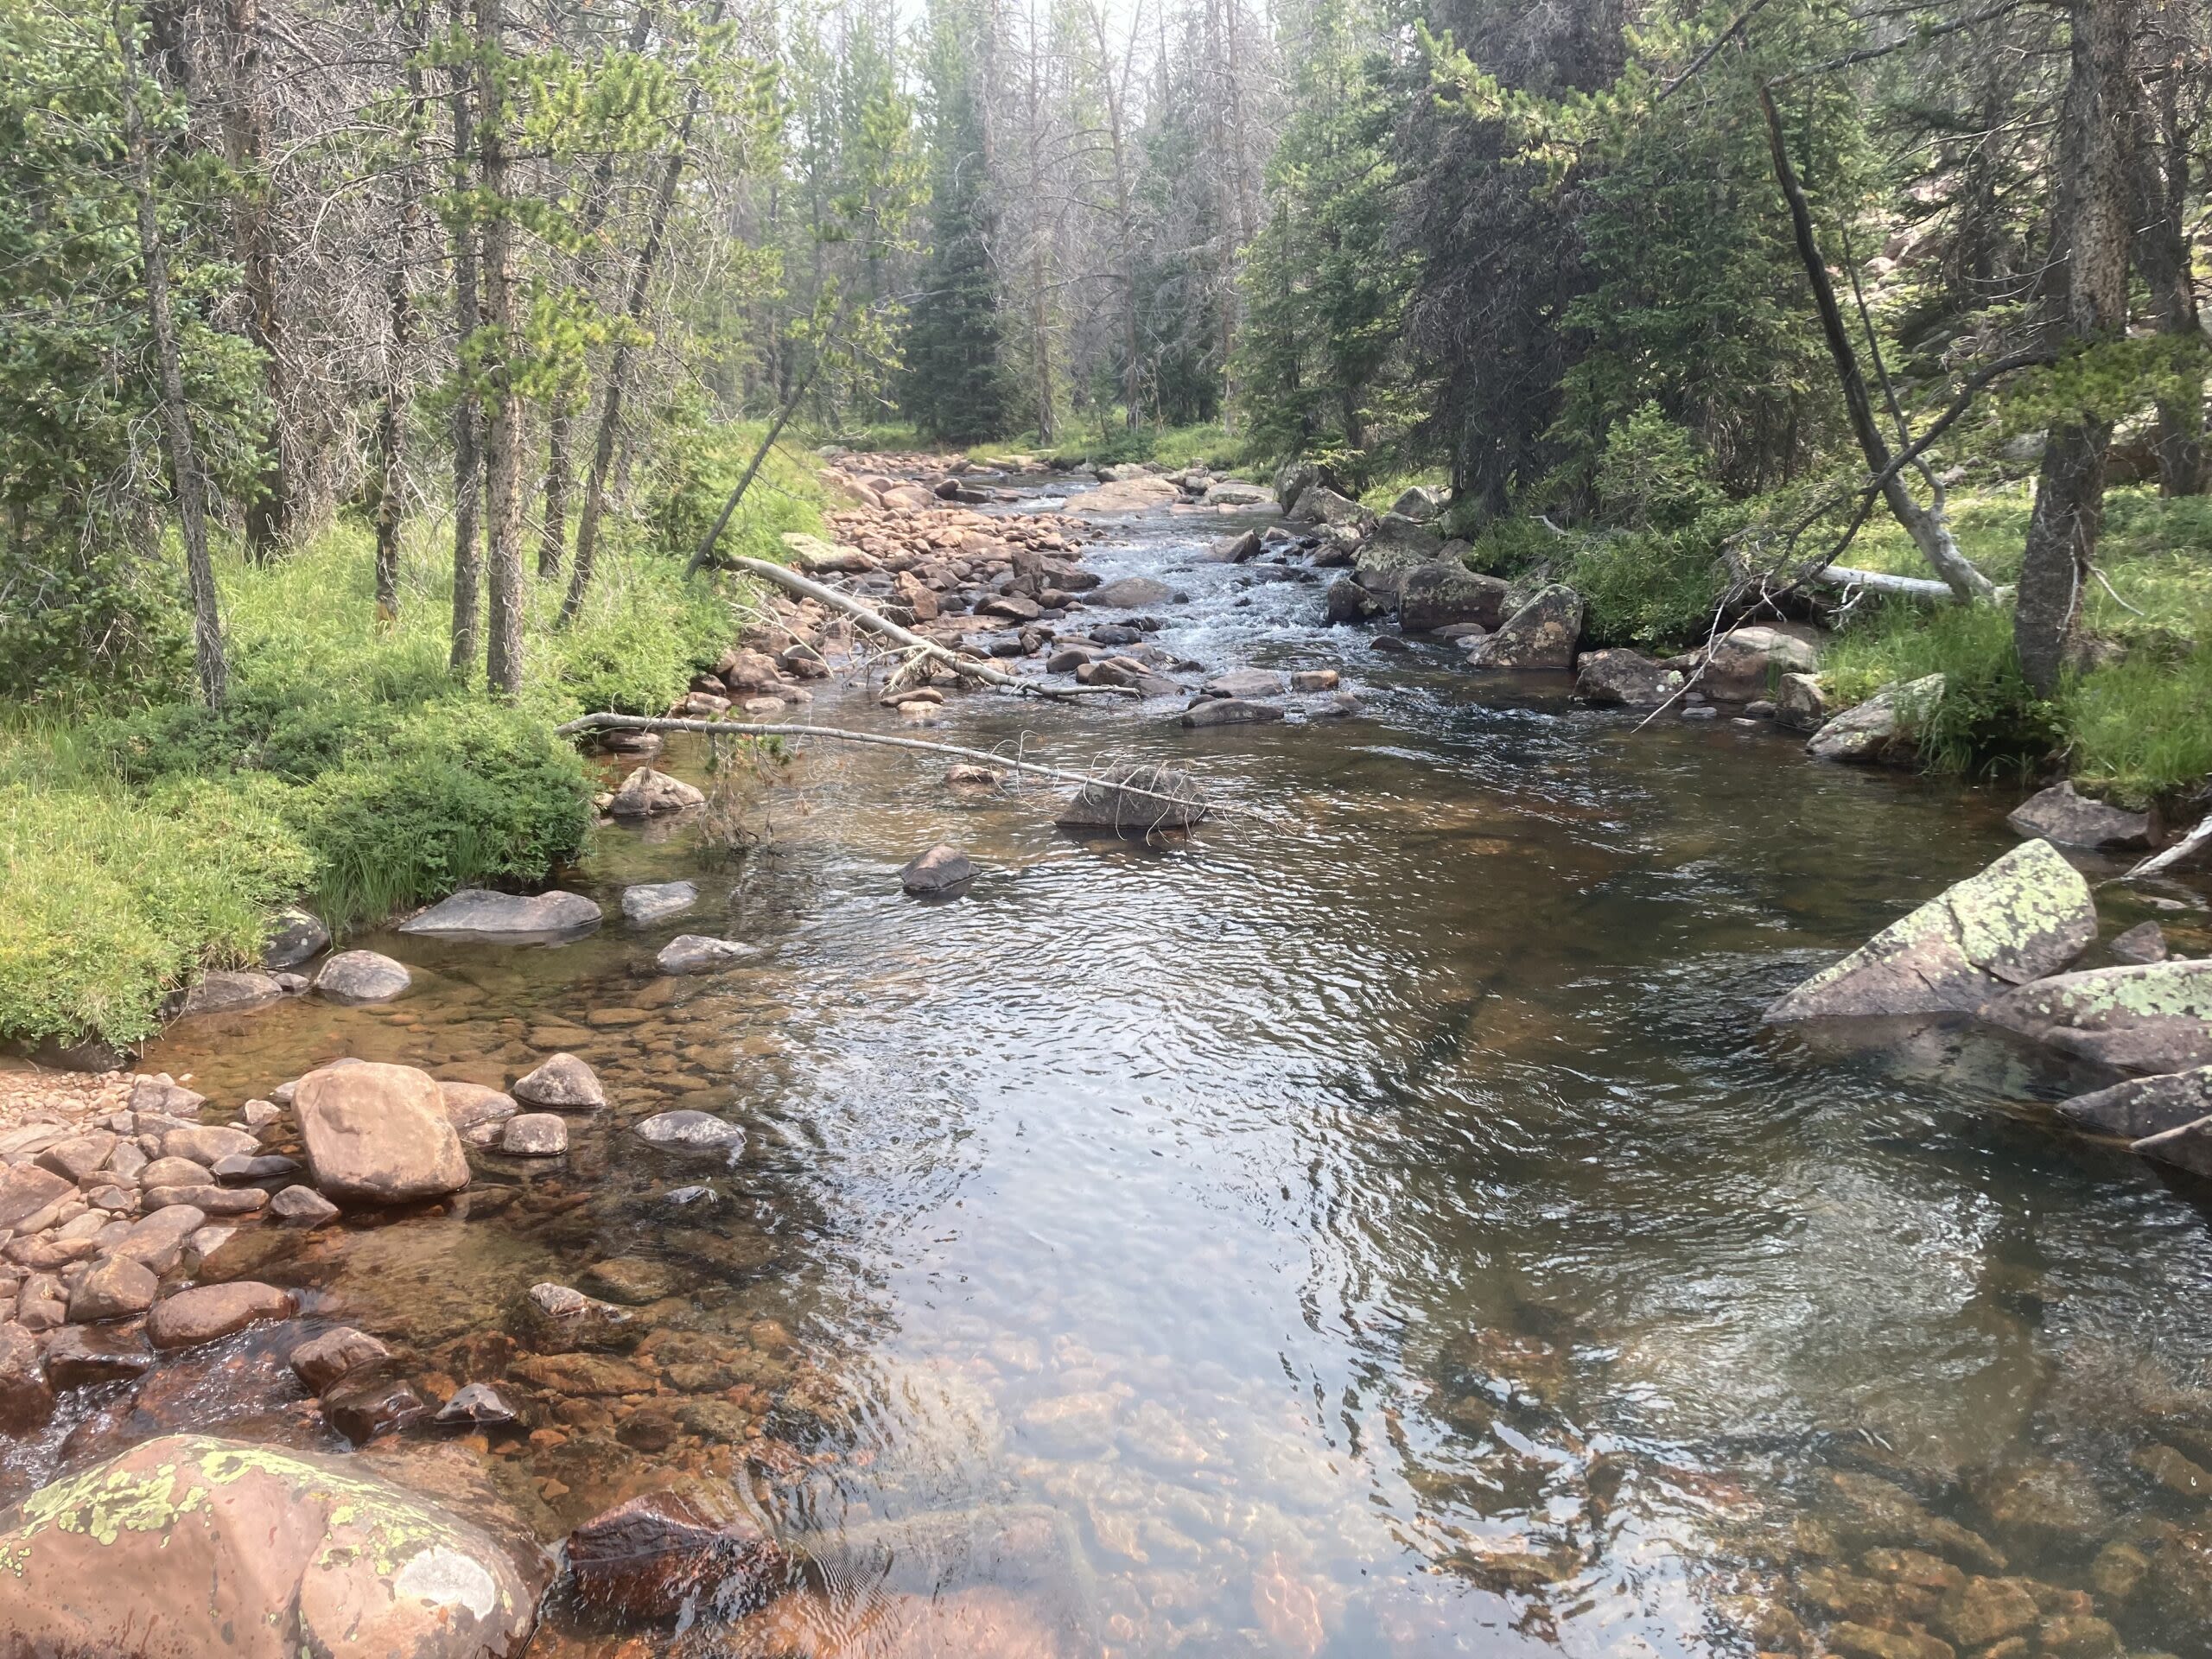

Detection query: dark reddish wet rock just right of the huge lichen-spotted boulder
xmin=566 ymin=1491 xmax=791 ymax=1619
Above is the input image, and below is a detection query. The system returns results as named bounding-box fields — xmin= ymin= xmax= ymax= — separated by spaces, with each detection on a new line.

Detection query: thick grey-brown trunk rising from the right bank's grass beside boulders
xmin=2013 ymin=0 xmax=2133 ymax=696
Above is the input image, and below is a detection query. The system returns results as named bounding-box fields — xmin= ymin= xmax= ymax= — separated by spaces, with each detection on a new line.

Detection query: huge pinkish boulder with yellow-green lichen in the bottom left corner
xmin=0 ymin=1435 xmax=546 ymax=1659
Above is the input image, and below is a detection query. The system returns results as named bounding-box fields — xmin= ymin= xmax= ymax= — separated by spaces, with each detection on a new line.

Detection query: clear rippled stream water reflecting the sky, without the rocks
xmin=129 ymin=499 xmax=2212 ymax=1655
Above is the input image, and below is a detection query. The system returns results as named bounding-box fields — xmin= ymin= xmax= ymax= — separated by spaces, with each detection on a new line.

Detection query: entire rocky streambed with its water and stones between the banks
xmin=0 ymin=458 xmax=2212 ymax=1659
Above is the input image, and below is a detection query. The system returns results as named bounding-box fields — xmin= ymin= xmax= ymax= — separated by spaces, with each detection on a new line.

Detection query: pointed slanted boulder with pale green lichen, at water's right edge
xmin=1765 ymin=841 xmax=2097 ymax=1022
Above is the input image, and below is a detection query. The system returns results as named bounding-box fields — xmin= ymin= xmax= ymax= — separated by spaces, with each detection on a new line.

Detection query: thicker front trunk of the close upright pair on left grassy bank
xmin=475 ymin=0 xmax=524 ymax=696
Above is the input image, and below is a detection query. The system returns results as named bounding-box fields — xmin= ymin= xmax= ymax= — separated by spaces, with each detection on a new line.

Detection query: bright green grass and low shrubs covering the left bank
xmin=0 ymin=431 xmax=821 ymax=1044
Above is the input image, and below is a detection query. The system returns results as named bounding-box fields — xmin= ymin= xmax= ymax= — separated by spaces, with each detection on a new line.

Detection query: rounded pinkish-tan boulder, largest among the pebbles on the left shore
xmin=292 ymin=1064 xmax=469 ymax=1204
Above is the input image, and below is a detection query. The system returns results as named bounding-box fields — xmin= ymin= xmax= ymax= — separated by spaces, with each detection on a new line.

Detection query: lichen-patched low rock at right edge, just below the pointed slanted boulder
xmin=1982 ymin=960 xmax=2212 ymax=1075
